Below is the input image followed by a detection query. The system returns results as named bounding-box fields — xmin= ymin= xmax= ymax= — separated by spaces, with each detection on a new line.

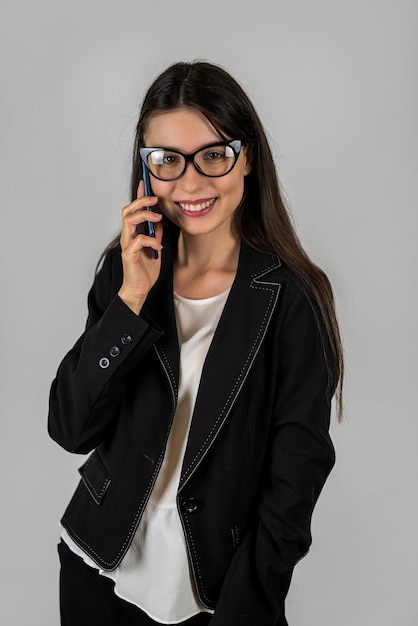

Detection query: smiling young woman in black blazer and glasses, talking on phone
xmin=49 ymin=62 xmax=342 ymax=626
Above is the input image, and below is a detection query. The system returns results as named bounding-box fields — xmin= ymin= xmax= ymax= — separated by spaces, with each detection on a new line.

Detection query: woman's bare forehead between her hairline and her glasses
xmin=144 ymin=107 xmax=223 ymax=152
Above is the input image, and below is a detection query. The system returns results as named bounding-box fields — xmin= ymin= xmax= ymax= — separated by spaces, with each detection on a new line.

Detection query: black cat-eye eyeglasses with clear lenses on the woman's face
xmin=139 ymin=139 xmax=242 ymax=181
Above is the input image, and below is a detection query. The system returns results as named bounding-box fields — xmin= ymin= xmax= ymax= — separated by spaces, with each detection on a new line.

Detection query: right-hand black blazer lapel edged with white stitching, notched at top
xmin=179 ymin=244 xmax=280 ymax=489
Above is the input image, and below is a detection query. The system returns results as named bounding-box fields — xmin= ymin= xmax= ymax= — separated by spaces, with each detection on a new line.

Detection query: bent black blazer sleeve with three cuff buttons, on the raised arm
xmin=48 ymin=249 xmax=162 ymax=454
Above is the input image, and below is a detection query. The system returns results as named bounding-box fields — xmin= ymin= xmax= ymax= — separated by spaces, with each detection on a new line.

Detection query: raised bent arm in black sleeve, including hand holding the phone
xmin=48 ymin=181 xmax=162 ymax=454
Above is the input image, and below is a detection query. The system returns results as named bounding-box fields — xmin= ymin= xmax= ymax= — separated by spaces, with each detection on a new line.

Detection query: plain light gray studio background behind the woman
xmin=0 ymin=0 xmax=418 ymax=626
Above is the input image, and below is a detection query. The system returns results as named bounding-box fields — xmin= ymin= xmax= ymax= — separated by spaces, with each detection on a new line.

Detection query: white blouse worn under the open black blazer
xmin=61 ymin=290 xmax=229 ymax=624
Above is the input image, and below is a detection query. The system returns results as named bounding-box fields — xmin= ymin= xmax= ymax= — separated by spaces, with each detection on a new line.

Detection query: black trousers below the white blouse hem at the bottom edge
xmin=58 ymin=541 xmax=211 ymax=626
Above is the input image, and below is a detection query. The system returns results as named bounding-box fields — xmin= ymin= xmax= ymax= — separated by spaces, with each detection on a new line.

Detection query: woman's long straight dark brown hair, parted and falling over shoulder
xmin=100 ymin=61 xmax=344 ymax=419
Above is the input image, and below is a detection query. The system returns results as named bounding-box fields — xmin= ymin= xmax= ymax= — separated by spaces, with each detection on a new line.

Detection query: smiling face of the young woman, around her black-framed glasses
xmin=145 ymin=108 xmax=251 ymax=235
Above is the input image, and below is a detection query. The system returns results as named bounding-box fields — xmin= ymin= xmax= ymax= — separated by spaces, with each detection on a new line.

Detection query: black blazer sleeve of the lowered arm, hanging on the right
xmin=211 ymin=292 xmax=335 ymax=626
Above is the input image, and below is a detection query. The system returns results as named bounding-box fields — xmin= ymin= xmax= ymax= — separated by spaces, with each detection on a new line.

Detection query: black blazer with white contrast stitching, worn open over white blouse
xmin=48 ymin=236 xmax=334 ymax=626
